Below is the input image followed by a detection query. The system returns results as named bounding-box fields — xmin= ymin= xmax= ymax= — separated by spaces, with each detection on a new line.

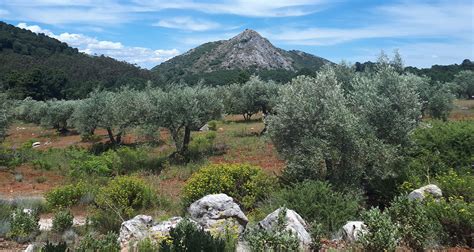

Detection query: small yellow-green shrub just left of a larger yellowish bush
xmin=45 ymin=183 xmax=86 ymax=209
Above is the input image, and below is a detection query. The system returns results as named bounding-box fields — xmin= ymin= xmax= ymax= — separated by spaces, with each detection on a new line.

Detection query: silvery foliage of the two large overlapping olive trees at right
xmin=269 ymin=64 xmax=421 ymax=185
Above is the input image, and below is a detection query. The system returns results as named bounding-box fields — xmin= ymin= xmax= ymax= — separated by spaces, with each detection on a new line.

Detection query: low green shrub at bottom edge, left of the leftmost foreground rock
xmin=75 ymin=232 xmax=120 ymax=252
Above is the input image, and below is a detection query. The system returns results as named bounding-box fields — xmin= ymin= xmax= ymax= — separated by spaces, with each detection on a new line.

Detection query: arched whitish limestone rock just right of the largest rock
xmin=258 ymin=208 xmax=312 ymax=247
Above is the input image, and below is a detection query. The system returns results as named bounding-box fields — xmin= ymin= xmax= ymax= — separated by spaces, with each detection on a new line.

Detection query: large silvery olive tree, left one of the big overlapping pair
xmin=268 ymin=69 xmax=360 ymax=184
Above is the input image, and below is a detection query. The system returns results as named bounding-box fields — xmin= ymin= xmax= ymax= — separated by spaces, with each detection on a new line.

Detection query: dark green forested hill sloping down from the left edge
xmin=0 ymin=21 xmax=152 ymax=100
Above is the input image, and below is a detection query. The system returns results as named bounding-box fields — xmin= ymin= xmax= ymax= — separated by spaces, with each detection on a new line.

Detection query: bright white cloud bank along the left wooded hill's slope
xmin=17 ymin=23 xmax=180 ymax=68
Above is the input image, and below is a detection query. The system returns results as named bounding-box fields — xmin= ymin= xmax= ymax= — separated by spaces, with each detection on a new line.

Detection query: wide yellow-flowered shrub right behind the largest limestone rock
xmin=183 ymin=164 xmax=274 ymax=209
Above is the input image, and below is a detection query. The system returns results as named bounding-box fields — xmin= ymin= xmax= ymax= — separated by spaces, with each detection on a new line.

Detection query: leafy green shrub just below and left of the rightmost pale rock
xmin=388 ymin=197 xmax=435 ymax=251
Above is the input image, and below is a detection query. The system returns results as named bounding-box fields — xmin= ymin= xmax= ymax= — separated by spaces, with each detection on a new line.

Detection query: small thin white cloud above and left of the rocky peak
xmin=153 ymin=17 xmax=220 ymax=31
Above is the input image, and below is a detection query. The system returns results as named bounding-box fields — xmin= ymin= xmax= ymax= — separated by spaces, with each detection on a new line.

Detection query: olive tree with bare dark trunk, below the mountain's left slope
xmin=154 ymin=86 xmax=223 ymax=157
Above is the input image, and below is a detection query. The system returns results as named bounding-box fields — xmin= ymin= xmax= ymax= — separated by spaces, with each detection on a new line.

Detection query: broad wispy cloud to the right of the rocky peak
xmin=264 ymin=1 xmax=474 ymax=45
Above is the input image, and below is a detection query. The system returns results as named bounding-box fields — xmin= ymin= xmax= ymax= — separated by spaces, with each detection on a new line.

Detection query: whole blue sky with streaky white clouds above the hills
xmin=0 ymin=0 xmax=474 ymax=68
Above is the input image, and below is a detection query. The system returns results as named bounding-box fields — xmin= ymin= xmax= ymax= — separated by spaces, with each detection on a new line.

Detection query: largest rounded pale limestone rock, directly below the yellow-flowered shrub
xmin=188 ymin=193 xmax=248 ymax=234
